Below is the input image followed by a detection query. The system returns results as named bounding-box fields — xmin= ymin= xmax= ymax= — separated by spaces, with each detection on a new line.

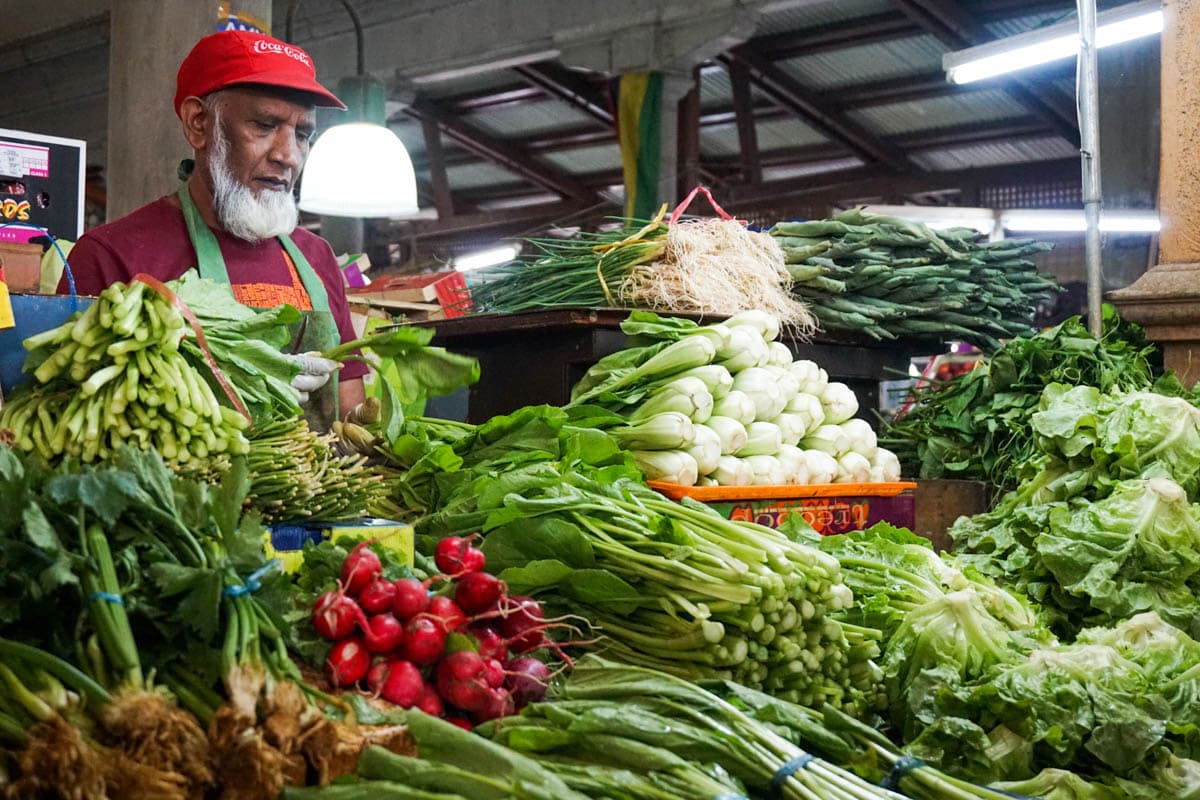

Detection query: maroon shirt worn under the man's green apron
xmin=58 ymin=196 xmax=367 ymax=380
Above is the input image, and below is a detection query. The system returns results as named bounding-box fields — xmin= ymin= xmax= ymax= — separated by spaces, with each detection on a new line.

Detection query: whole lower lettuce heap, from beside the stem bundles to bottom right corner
xmin=812 ymin=525 xmax=1200 ymax=800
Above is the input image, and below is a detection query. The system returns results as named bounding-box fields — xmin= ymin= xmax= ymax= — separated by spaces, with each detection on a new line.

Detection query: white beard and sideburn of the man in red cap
xmin=208 ymin=119 xmax=300 ymax=242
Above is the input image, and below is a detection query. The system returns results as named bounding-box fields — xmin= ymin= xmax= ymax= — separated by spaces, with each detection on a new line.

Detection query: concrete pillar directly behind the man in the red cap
xmin=106 ymin=0 xmax=271 ymax=221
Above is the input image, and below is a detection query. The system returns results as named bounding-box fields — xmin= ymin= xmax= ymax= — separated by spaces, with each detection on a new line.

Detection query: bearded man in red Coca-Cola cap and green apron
xmin=59 ymin=31 xmax=366 ymax=427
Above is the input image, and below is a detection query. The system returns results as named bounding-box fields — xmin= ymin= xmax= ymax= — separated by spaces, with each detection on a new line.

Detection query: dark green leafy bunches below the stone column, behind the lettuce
xmin=880 ymin=306 xmax=1183 ymax=489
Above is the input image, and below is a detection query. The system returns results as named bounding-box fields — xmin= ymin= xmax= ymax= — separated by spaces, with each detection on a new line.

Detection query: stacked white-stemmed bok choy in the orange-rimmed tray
xmin=568 ymin=312 xmax=900 ymax=486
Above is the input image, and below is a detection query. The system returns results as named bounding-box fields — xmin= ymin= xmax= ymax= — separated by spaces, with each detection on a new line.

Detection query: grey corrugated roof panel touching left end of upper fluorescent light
xmin=779 ymin=35 xmax=946 ymax=89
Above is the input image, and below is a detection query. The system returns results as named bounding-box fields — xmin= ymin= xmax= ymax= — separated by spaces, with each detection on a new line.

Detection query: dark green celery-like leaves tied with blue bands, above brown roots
xmin=0 ymin=447 xmax=295 ymax=705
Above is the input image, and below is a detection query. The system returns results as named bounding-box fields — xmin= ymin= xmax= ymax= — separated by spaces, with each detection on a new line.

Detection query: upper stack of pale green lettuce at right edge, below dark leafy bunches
xmin=950 ymin=386 xmax=1200 ymax=637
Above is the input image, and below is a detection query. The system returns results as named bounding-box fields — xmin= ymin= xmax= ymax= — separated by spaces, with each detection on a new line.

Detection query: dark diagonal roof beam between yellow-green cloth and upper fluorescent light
xmin=720 ymin=47 xmax=912 ymax=172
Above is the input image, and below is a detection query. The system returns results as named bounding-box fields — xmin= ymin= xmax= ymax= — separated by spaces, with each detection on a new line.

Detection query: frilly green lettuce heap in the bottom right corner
xmin=907 ymin=613 xmax=1200 ymax=796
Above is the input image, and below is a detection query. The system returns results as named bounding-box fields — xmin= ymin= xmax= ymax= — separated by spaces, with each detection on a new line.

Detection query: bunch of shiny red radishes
xmin=312 ymin=536 xmax=556 ymax=729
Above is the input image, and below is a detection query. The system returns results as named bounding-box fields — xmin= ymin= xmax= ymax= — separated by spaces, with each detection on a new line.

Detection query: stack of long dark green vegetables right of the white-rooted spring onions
xmin=770 ymin=209 xmax=1058 ymax=349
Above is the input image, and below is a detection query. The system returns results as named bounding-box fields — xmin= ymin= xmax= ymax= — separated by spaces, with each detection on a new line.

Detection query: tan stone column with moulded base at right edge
xmin=1109 ymin=0 xmax=1200 ymax=385
